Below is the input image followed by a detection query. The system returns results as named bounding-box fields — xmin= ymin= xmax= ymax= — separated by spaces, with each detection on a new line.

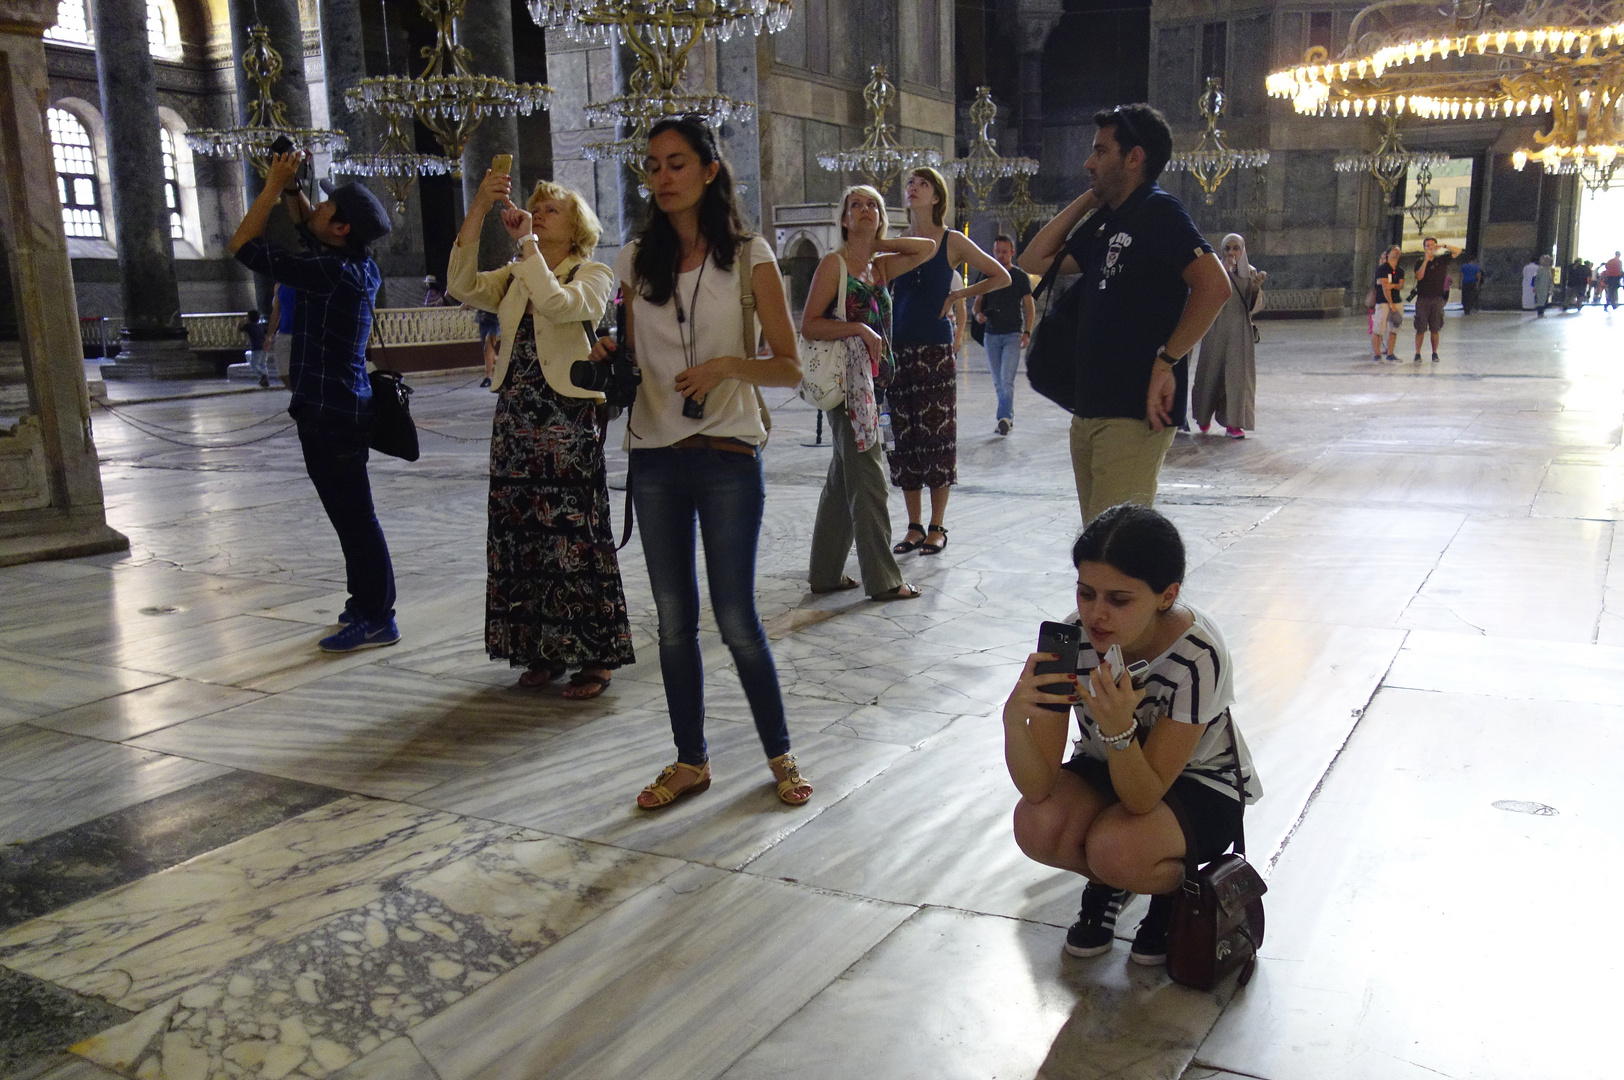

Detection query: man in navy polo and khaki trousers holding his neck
xmin=1020 ymin=104 xmax=1229 ymax=525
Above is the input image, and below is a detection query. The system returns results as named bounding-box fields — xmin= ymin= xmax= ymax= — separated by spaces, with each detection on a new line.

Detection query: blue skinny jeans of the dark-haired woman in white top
xmin=630 ymin=448 xmax=789 ymax=767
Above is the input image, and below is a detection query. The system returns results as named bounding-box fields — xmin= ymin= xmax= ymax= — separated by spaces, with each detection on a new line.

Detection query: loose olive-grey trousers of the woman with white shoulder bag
xmin=807 ymin=404 xmax=903 ymax=596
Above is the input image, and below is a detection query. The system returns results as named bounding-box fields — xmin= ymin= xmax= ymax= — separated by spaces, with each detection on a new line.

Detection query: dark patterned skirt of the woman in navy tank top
xmin=885 ymin=344 xmax=958 ymax=490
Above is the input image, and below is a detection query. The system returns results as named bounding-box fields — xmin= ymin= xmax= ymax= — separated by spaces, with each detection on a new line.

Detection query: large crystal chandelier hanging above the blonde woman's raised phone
xmin=344 ymin=0 xmax=552 ymax=177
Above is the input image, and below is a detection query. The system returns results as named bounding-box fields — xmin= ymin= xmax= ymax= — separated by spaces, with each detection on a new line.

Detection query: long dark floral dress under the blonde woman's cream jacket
xmin=486 ymin=315 xmax=635 ymax=667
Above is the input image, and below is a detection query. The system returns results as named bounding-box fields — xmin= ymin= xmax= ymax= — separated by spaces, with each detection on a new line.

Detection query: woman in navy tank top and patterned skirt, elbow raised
xmin=885 ymin=167 xmax=1010 ymax=555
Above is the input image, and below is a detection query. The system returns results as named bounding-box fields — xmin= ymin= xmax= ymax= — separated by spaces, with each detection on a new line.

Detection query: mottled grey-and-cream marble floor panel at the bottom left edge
xmin=73 ymin=833 xmax=680 ymax=1080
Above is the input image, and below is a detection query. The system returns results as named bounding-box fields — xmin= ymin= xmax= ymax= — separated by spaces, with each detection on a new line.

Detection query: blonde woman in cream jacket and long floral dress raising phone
xmin=447 ymin=172 xmax=633 ymax=698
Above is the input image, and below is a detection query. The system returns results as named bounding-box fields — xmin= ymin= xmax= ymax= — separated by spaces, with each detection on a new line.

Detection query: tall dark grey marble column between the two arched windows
xmin=93 ymin=0 xmax=203 ymax=378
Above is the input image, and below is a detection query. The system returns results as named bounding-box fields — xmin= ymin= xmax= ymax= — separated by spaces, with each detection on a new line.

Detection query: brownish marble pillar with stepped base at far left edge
xmin=0 ymin=0 xmax=128 ymax=565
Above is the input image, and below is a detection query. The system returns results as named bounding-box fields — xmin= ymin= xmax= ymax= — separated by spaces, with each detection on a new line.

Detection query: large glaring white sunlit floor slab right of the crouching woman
xmin=1199 ymin=690 xmax=1624 ymax=1080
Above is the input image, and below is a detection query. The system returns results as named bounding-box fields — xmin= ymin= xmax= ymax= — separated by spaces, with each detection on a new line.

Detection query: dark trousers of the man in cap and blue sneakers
xmin=299 ymin=416 xmax=395 ymax=622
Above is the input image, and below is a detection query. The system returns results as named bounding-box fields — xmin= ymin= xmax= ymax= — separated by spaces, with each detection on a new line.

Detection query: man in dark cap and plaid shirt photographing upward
xmin=229 ymin=153 xmax=401 ymax=653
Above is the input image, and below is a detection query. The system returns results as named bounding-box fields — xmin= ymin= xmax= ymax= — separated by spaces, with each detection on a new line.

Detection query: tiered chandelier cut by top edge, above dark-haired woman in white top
xmin=529 ymin=0 xmax=793 ymax=182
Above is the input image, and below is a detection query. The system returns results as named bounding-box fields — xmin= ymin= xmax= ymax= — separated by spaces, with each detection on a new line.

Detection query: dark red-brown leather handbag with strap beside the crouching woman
xmin=1168 ymin=721 xmax=1268 ymax=991
